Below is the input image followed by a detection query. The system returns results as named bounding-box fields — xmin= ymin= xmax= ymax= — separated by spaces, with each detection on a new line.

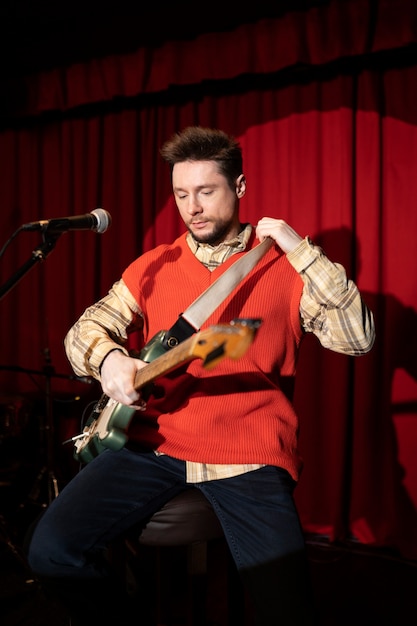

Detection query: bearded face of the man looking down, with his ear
xmin=172 ymin=161 xmax=244 ymax=245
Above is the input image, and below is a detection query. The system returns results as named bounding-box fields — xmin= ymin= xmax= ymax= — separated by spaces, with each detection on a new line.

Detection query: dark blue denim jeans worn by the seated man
xmin=28 ymin=448 xmax=314 ymax=626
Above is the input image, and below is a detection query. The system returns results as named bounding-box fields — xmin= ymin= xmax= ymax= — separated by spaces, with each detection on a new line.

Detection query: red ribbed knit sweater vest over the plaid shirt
xmin=123 ymin=235 xmax=303 ymax=480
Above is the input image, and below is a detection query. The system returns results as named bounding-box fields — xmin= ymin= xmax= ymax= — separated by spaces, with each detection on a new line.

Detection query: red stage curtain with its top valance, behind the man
xmin=0 ymin=0 xmax=417 ymax=558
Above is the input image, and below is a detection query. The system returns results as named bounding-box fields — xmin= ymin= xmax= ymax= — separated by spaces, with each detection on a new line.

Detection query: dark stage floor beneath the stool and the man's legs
xmin=0 ymin=502 xmax=417 ymax=626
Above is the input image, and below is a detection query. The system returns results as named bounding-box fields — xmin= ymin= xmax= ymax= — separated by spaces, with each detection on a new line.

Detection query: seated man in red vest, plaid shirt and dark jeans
xmin=29 ymin=127 xmax=374 ymax=626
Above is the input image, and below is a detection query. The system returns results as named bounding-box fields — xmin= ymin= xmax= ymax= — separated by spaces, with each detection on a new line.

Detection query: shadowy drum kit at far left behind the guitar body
xmin=0 ymin=363 xmax=94 ymax=508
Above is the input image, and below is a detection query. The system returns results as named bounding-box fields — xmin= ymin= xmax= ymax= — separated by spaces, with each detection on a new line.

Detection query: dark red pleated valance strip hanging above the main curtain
xmin=3 ymin=0 xmax=417 ymax=116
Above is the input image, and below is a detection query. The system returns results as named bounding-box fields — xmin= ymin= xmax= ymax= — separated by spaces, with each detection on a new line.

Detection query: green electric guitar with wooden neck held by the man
xmin=72 ymin=319 xmax=261 ymax=463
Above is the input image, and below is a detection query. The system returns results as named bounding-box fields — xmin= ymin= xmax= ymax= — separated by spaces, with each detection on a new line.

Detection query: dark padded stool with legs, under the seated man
xmin=116 ymin=488 xmax=245 ymax=626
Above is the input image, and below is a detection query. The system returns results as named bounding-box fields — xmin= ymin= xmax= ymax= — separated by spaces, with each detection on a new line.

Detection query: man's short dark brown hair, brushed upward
xmin=160 ymin=126 xmax=243 ymax=189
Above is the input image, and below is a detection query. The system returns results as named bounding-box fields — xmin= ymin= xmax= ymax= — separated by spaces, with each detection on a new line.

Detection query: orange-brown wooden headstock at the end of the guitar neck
xmin=192 ymin=318 xmax=262 ymax=369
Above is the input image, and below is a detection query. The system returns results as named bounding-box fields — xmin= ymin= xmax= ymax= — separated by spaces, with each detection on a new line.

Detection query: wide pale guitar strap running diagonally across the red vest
xmin=162 ymin=237 xmax=274 ymax=350
